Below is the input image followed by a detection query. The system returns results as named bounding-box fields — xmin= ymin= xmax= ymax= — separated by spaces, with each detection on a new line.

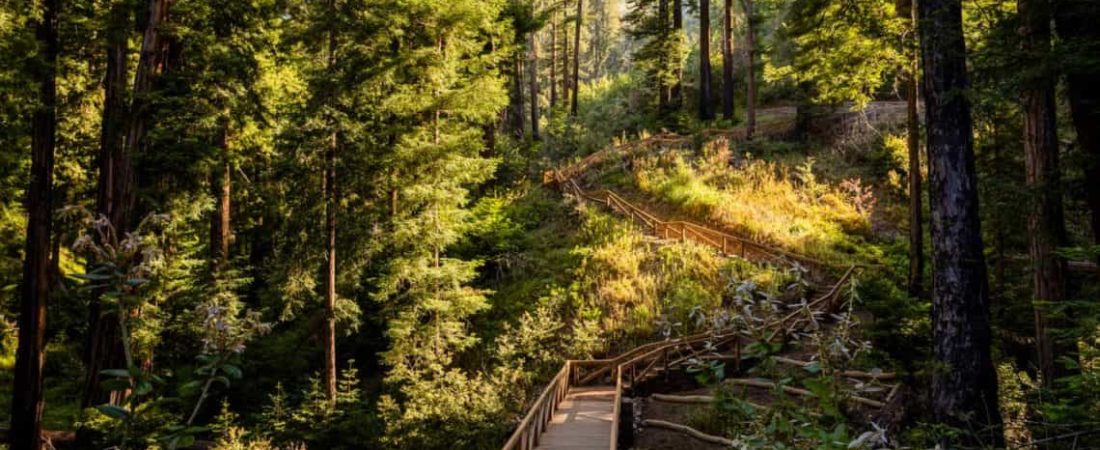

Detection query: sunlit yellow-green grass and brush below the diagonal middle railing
xmin=571 ymin=204 xmax=798 ymax=342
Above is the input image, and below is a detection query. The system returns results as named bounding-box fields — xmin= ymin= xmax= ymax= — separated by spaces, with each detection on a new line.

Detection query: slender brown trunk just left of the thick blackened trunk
xmin=895 ymin=0 xmax=924 ymax=298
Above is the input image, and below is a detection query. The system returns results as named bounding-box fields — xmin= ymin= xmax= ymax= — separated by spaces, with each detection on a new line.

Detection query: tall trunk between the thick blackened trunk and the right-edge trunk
xmin=1016 ymin=0 xmax=1073 ymax=386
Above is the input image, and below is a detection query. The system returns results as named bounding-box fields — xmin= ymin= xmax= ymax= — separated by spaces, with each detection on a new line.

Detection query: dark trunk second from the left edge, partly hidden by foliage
xmin=80 ymin=2 xmax=132 ymax=409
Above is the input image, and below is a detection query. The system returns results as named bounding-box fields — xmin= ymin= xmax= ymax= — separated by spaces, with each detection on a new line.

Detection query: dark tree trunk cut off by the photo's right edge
xmin=1054 ymin=0 xmax=1100 ymax=243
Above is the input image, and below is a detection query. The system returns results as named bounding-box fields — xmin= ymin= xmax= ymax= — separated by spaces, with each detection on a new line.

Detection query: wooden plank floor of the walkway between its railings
xmin=536 ymin=386 xmax=615 ymax=450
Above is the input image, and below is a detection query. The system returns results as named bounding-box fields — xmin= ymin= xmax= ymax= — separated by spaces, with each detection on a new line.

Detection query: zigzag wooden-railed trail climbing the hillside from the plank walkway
xmin=503 ymin=102 xmax=904 ymax=450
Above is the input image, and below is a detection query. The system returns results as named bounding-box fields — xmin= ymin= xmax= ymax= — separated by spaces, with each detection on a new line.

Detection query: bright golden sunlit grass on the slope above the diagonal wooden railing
xmin=633 ymin=146 xmax=870 ymax=261
